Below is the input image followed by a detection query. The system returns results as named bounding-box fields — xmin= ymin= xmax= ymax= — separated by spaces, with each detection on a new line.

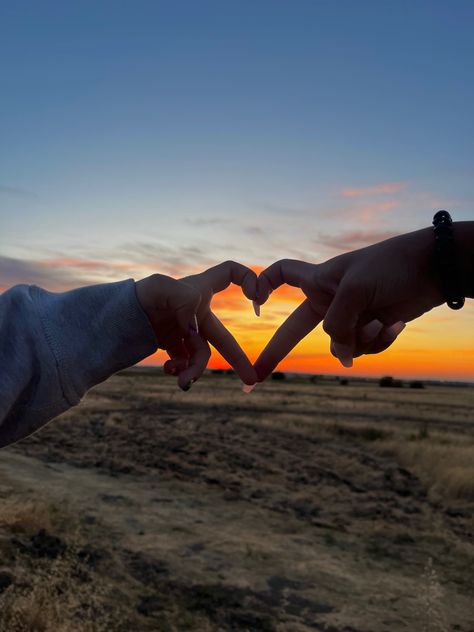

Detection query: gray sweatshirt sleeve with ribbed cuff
xmin=0 ymin=279 xmax=157 ymax=447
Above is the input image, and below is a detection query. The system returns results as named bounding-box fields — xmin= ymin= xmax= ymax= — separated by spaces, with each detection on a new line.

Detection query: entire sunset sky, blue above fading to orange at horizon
xmin=0 ymin=0 xmax=474 ymax=380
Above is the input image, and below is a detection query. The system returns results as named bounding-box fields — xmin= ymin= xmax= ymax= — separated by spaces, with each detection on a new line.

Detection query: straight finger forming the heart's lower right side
xmin=254 ymin=300 xmax=322 ymax=382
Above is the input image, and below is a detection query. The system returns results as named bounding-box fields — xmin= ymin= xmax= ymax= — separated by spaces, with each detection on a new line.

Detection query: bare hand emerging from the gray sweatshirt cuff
xmin=136 ymin=261 xmax=257 ymax=390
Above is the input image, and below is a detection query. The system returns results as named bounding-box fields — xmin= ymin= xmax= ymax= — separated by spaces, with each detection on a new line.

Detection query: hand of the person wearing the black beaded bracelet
xmin=254 ymin=229 xmax=444 ymax=381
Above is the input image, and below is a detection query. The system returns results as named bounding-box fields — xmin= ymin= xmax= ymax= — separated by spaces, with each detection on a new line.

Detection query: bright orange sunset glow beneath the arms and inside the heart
xmin=142 ymin=286 xmax=474 ymax=381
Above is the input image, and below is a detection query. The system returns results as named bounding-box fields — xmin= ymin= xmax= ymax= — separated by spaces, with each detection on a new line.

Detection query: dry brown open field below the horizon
xmin=0 ymin=372 xmax=474 ymax=632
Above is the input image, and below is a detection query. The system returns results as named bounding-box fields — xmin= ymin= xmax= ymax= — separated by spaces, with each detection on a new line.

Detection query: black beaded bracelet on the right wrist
xmin=433 ymin=211 xmax=464 ymax=309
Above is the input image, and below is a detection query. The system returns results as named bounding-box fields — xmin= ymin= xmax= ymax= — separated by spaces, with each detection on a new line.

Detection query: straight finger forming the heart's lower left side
xmin=200 ymin=312 xmax=257 ymax=384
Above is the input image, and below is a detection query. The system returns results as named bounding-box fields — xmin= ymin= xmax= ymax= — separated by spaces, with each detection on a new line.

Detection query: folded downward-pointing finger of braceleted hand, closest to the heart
xmin=323 ymin=280 xmax=366 ymax=368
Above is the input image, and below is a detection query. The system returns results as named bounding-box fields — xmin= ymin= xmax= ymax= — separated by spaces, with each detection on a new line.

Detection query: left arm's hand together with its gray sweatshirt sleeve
xmin=0 ymin=262 xmax=257 ymax=448
